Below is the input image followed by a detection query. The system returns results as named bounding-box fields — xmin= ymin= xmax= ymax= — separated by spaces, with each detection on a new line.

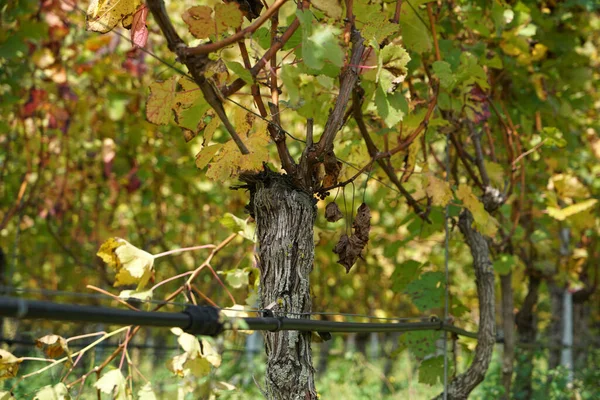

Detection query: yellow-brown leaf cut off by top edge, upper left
xmin=86 ymin=0 xmax=142 ymax=33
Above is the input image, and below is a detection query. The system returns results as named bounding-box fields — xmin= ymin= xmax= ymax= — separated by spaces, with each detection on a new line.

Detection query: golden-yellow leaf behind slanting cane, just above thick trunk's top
xmin=206 ymin=113 xmax=270 ymax=181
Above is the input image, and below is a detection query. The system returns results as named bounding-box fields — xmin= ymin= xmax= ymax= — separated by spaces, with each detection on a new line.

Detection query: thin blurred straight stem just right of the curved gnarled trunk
xmin=500 ymin=272 xmax=515 ymax=399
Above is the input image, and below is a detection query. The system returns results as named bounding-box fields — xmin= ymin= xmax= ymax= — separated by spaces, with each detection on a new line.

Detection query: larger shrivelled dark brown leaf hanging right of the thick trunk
xmin=333 ymin=203 xmax=371 ymax=273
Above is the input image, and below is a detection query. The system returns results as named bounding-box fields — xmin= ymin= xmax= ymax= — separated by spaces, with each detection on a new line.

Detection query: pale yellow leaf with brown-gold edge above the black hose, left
xmin=96 ymin=238 xmax=154 ymax=290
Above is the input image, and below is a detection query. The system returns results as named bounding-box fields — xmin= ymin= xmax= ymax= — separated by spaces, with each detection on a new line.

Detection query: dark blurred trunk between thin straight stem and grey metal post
xmin=513 ymin=275 xmax=541 ymax=399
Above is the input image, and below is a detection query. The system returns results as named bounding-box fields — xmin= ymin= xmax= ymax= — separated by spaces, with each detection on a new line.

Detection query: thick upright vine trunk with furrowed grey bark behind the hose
xmin=240 ymin=170 xmax=317 ymax=400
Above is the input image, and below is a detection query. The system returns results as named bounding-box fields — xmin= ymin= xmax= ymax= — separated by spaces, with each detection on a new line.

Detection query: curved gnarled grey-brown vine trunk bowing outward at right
xmin=437 ymin=210 xmax=496 ymax=399
